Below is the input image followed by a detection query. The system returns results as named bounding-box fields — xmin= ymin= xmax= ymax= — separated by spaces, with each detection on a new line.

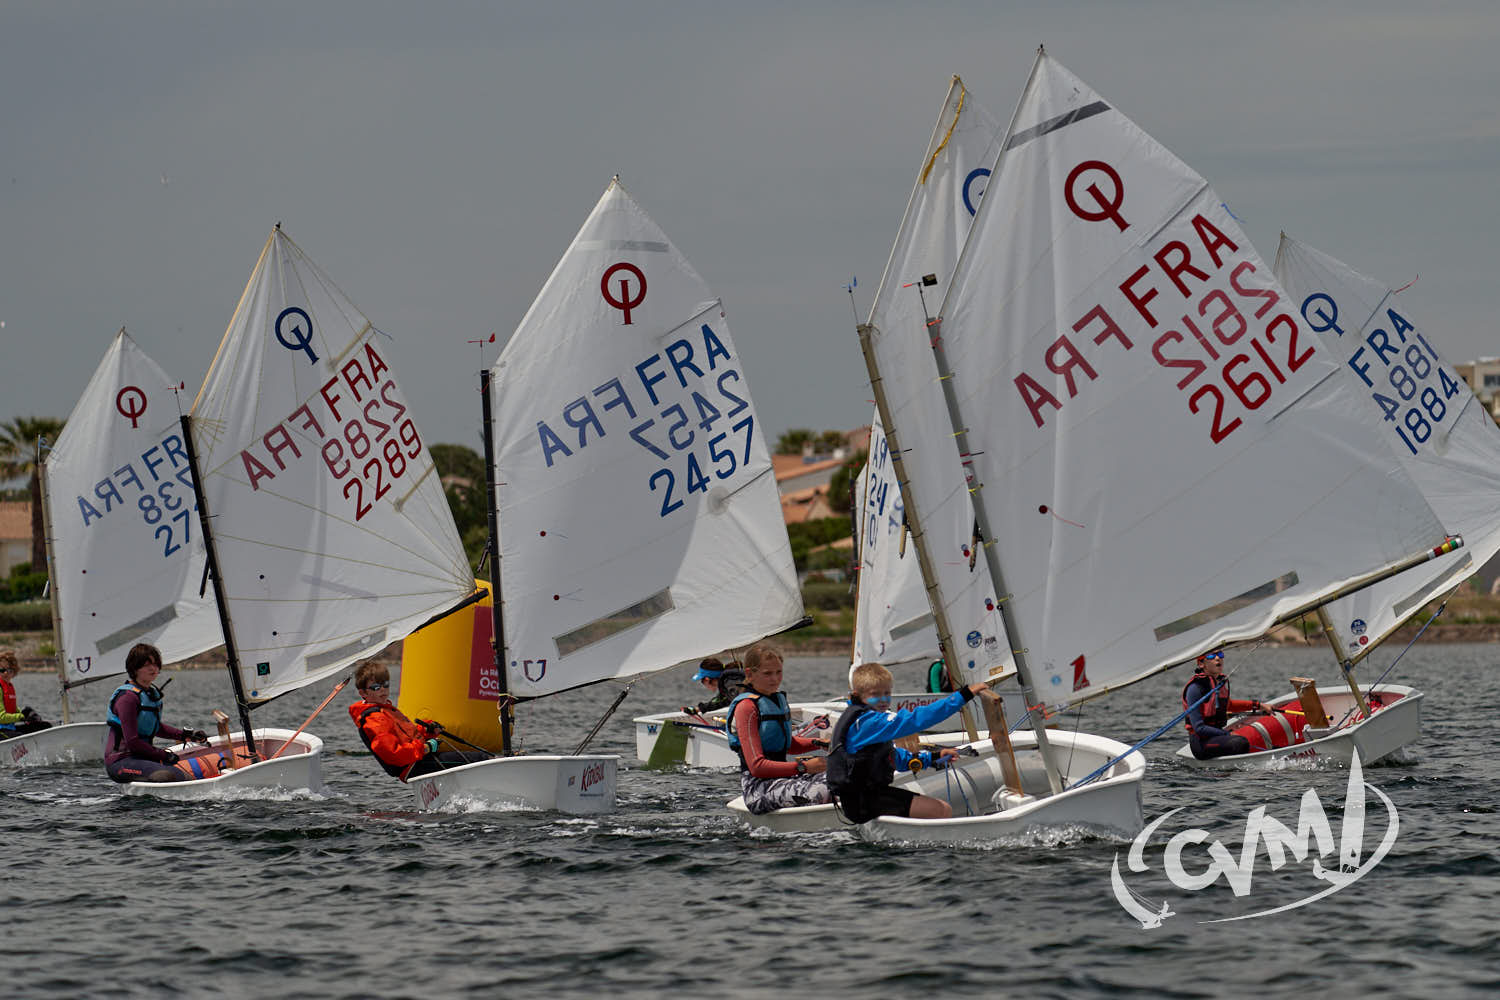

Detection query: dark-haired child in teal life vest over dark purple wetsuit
xmin=104 ymin=642 xmax=209 ymax=783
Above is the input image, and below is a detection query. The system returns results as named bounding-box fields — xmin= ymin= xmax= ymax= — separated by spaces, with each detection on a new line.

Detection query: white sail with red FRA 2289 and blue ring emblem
xmin=192 ymin=228 xmax=474 ymax=700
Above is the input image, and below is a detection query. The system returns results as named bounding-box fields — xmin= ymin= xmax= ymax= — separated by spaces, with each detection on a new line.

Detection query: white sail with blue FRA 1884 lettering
xmin=1275 ymin=235 xmax=1500 ymax=657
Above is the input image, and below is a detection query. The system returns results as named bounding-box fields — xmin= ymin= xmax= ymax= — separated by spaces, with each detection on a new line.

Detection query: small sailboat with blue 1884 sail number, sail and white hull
xmin=1178 ymin=234 xmax=1500 ymax=766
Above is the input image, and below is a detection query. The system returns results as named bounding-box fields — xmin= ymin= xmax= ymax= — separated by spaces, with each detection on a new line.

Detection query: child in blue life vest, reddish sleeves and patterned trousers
xmin=729 ymin=643 xmax=828 ymax=814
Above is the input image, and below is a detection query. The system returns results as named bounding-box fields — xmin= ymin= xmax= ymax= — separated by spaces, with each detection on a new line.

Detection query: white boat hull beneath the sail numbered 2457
xmin=407 ymin=754 xmax=620 ymax=816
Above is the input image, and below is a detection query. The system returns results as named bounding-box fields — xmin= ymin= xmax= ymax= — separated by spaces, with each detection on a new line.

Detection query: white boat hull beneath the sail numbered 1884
xmin=1176 ymin=684 xmax=1422 ymax=768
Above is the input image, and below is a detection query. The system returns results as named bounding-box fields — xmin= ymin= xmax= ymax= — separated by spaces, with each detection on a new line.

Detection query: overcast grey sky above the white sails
xmin=0 ymin=0 xmax=1500 ymax=458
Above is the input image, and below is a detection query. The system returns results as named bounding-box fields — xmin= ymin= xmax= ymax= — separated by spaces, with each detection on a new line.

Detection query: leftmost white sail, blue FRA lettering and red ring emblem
xmin=47 ymin=330 xmax=224 ymax=684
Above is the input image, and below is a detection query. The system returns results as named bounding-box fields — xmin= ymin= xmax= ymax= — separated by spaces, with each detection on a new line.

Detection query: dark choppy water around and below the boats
xmin=0 ymin=645 xmax=1500 ymax=997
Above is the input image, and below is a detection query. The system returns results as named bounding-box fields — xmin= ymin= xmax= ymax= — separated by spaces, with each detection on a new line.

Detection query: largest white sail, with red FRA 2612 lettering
xmin=918 ymin=55 xmax=1445 ymax=705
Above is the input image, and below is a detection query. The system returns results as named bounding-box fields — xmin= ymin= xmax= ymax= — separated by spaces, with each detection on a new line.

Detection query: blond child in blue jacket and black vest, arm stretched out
xmin=828 ymin=663 xmax=986 ymax=823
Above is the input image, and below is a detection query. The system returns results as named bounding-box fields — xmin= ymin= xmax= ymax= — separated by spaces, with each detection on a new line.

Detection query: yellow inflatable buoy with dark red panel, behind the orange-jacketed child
xmin=396 ymin=580 xmax=500 ymax=753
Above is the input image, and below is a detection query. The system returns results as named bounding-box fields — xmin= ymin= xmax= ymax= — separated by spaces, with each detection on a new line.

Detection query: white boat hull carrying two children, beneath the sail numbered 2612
xmin=729 ymin=730 xmax=1146 ymax=844
